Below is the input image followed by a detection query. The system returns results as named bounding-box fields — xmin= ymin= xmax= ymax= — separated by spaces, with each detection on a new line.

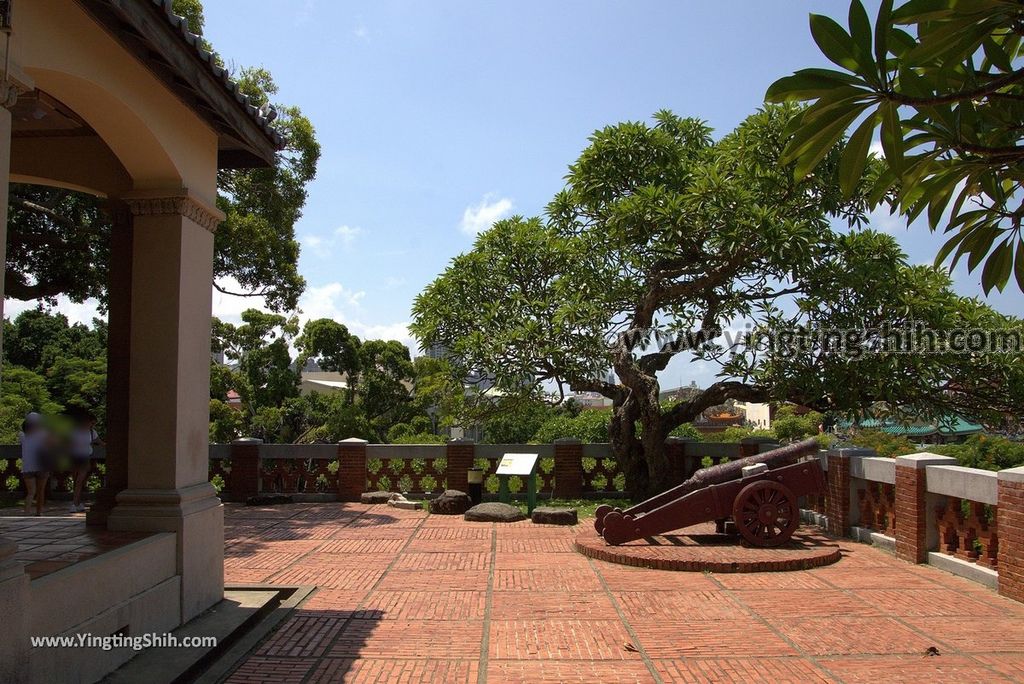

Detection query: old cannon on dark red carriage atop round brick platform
xmin=594 ymin=439 xmax=824 ymax=547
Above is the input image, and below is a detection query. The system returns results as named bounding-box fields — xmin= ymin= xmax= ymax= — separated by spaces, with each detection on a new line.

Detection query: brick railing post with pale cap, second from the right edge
xmin=894 ymin=454 xmax=956 ymax=563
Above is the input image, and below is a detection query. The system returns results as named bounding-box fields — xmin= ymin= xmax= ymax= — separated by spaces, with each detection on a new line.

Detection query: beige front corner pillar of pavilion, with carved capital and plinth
xmin=108 ymin=190 xmax=224 ymax=622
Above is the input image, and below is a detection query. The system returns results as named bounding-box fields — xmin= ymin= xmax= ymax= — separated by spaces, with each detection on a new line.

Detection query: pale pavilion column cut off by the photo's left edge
xmin=0 ymin=78 xmax=30 ymax=682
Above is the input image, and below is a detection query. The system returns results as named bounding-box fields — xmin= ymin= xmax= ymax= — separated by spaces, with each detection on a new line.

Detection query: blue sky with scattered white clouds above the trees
xmin=9 ymin=0 xmax=1024 ymax=386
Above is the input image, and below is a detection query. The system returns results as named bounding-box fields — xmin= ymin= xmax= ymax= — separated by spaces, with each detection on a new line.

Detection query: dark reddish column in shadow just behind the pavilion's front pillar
xmin=85 ymin=200 xmax=132 ymax=525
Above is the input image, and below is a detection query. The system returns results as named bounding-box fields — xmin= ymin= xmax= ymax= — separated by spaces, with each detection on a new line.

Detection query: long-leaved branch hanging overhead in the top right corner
xmin=765 ymin=0 xmax=1024 ymax=293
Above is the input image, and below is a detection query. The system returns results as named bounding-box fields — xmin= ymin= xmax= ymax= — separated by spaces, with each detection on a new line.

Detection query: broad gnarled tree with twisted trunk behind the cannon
xmin=412 ymin=106 xmax=1021 ymax=496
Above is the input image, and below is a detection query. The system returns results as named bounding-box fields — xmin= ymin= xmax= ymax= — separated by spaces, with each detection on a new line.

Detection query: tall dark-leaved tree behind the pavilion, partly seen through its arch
xmin=4 ymin=0 xmax=321 ymax=311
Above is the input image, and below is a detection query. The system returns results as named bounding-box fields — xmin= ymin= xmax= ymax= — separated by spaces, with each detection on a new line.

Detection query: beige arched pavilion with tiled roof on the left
xmin=0 ymin=0 xmax=284 ymax=682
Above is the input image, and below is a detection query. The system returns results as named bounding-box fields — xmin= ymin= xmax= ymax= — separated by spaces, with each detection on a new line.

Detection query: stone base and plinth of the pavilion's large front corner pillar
xmin=106 ymin=482 xmax=224 ymax=623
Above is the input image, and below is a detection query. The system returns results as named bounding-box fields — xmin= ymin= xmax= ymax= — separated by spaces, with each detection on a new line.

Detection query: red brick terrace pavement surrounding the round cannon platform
xmin=224 ymin=504 xmax=1024 ymax=684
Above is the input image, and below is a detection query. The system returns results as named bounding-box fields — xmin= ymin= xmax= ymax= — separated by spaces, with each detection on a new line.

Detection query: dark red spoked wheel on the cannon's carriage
xmin=732 ymin=480 xmax=800 ymax=547
